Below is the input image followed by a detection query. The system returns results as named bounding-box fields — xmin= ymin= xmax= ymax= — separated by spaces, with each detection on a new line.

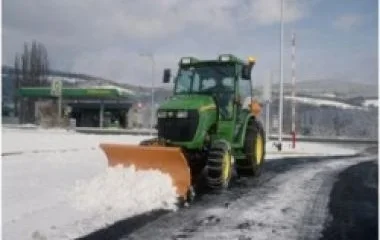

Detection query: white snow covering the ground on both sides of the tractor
xmin=2 ymin=129 xmax=362 ymax=239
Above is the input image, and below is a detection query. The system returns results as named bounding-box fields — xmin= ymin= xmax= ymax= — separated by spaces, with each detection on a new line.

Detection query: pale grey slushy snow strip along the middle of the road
xmin=168 ymin=158 xmax=372 ymax=239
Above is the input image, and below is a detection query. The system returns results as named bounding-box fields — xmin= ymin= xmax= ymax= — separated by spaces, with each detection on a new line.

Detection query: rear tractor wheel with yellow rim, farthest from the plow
xmin=236 ymin=120 xmax=265 ymax=176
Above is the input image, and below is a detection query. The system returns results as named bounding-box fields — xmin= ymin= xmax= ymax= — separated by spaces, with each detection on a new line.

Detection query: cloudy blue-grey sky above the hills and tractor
xmin=2 ymin=0 xmax=378 ymax=85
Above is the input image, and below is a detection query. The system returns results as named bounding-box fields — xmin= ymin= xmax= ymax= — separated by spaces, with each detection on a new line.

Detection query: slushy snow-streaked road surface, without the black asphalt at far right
xmin=81 ymin=152 xmax=377 ymax=240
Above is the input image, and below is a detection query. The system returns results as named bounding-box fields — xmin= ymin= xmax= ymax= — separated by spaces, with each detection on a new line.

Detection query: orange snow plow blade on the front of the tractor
xmin=100 ymin=144 xmax=191 ymax=199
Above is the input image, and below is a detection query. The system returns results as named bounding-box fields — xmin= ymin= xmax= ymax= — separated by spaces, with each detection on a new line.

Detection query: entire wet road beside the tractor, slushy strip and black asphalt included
xmin=80 ymin=148 xmax=378 ymax=240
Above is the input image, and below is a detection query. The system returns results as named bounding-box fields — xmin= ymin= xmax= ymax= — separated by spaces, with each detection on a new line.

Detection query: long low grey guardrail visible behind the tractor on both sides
xmin=75 ymin=127 xmax=378 ymax=144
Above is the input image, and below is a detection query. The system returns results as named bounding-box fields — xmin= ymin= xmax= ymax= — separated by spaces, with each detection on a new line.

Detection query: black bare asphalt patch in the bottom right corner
xmin=321 ymin=161 xmax=379 ymax=240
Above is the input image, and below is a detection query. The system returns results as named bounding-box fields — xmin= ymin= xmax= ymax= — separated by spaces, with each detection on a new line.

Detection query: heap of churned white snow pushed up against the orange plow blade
xmin=68 ymin=166 xmax=177 ymax=224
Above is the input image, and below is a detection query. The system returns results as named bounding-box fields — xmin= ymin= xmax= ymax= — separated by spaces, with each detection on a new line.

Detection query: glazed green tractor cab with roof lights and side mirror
xmin=163 ymin=54 xmax=255 ymax=121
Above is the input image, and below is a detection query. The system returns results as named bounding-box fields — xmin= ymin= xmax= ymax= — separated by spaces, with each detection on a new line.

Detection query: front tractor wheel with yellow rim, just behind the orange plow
xmin=206 ymin=140 xmax=233 ymax=190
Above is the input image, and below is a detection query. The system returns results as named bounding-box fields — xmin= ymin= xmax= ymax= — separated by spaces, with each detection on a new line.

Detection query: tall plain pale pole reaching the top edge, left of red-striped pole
xmin=277 ymin=0 xmax=284 ymax=151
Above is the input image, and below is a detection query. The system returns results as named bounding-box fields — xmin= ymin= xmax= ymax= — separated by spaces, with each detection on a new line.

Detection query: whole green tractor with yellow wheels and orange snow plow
xmin=101 ymin=54 xmax=265 ymax=199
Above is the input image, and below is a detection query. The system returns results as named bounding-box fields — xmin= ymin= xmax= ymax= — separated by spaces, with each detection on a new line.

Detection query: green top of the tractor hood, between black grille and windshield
xmin=160 ymin=94 xmax=216 ymax=111
